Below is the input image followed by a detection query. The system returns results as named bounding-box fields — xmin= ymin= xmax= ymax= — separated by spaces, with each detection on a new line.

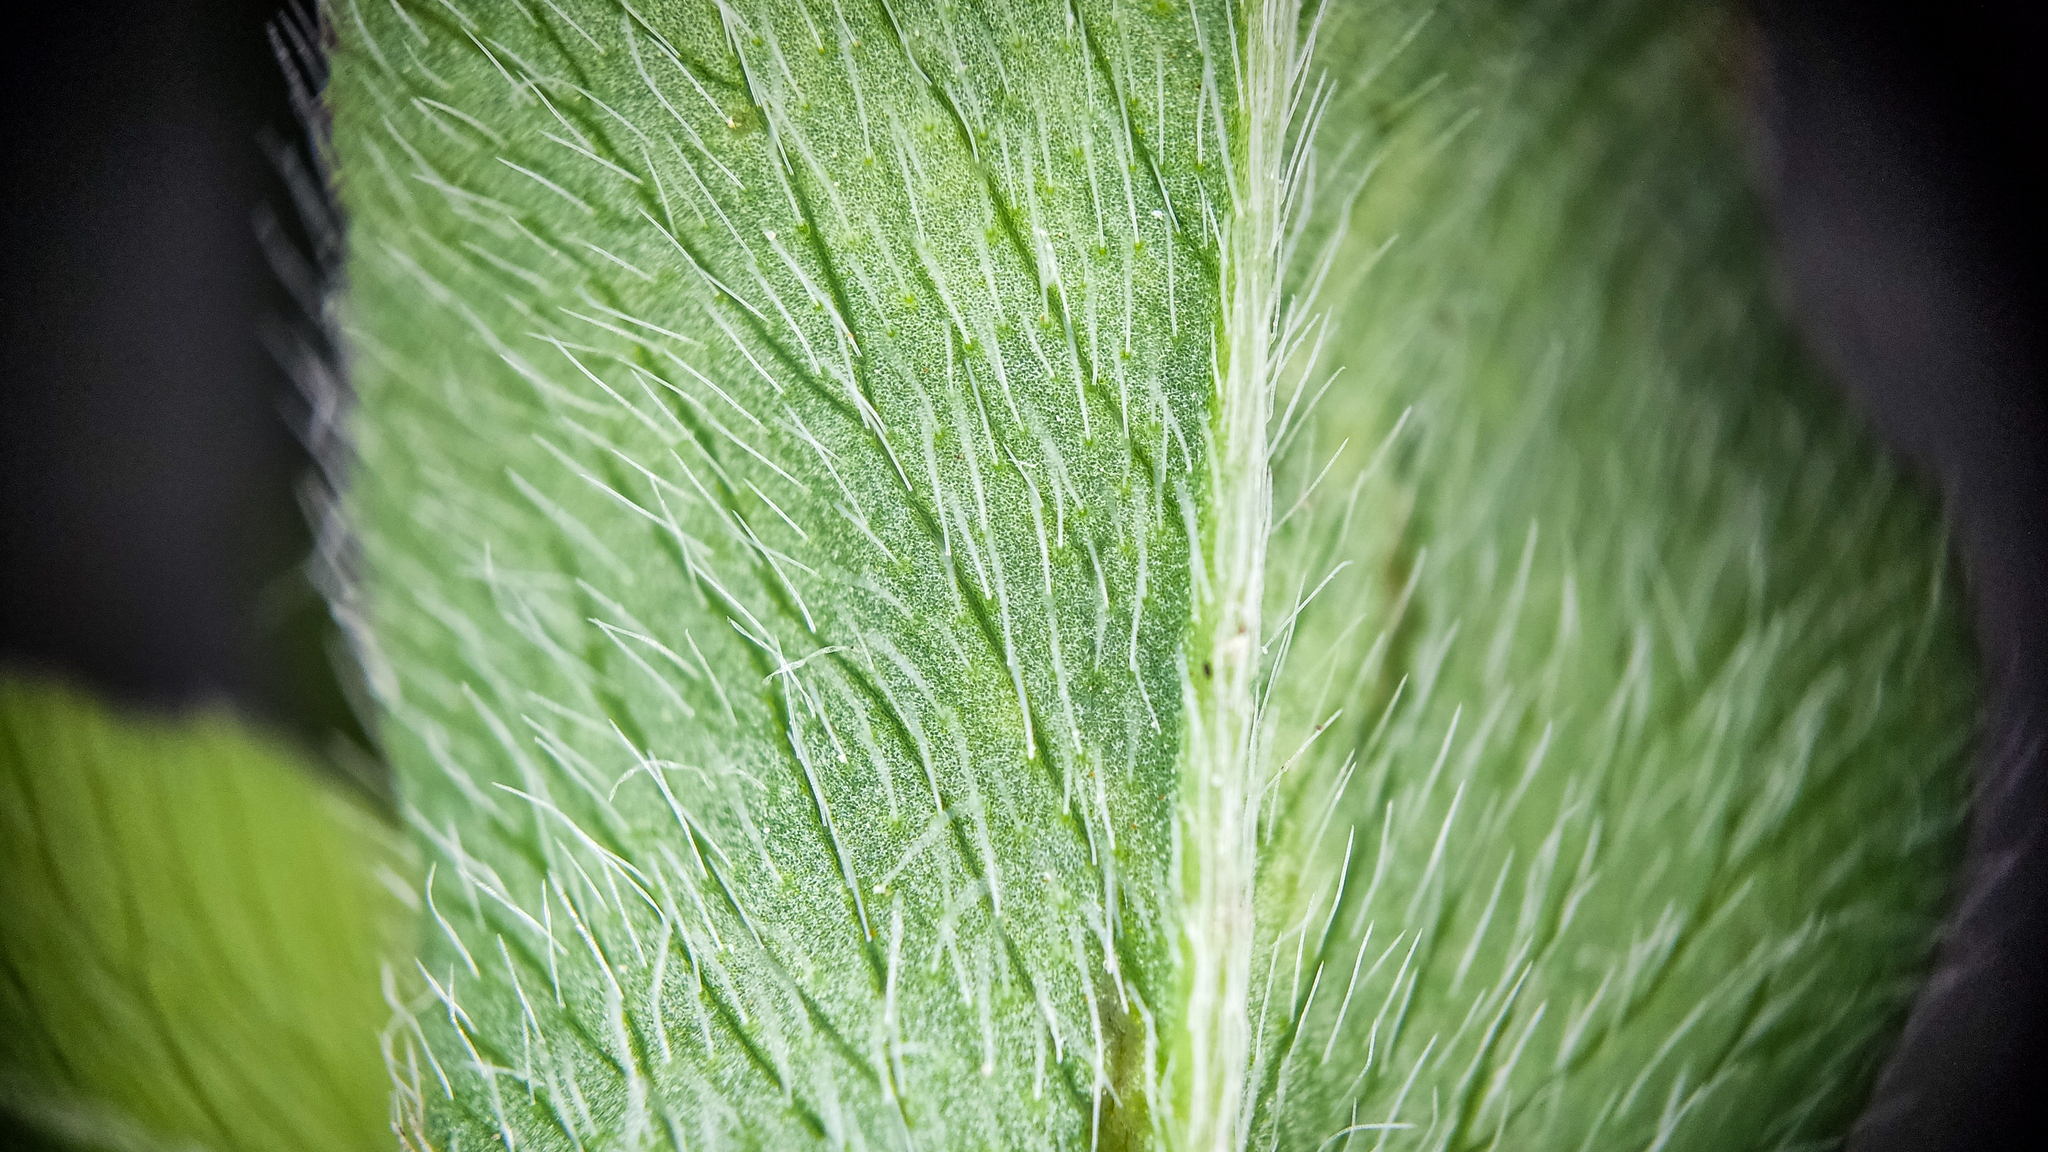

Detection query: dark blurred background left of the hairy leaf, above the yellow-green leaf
xmin=0 ymin=0 xmax=350 ymax=746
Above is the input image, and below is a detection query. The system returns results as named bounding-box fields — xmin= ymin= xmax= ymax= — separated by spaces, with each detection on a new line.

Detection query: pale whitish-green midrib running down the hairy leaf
xmin=1167 ymin=0 xmax=1298 ymax=1152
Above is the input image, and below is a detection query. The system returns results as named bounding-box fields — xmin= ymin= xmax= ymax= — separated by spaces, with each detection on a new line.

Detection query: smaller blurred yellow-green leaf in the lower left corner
xmin=0 ymin=672 xmax=414 ymax=1152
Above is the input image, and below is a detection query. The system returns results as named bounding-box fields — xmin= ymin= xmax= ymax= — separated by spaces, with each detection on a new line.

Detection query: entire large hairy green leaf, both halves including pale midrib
xmin=328 ymin=0 xmax=1974 ymax=1152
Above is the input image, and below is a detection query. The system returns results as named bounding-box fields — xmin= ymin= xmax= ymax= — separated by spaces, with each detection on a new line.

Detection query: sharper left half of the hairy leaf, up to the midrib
xmin=334 ymin=4 xmax=1229 ymax=1146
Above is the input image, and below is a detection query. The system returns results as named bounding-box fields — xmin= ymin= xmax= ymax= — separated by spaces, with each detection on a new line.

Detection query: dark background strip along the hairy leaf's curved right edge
xmin=1757 ymin=0 xmax=2048 ymax=1152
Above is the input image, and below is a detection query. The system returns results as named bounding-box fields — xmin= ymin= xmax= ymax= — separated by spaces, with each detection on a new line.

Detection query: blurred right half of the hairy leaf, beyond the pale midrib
xmin=1262 ymin=4 xmax=1974 ymax=1148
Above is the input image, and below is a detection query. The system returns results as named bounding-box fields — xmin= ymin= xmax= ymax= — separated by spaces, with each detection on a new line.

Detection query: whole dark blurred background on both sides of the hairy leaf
xmin=0 ymin=0 xmax=2048 ymax=1152
